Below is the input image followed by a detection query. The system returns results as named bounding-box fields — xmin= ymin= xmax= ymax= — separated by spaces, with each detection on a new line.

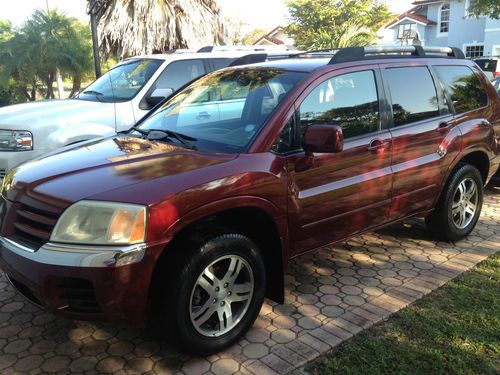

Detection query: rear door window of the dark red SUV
xmin=385 ymin=67 xmax=439 ymax=126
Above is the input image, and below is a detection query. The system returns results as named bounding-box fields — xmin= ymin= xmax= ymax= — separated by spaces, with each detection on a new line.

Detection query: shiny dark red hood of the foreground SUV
xmin=4 ymin=136 xmax=236 ymax=208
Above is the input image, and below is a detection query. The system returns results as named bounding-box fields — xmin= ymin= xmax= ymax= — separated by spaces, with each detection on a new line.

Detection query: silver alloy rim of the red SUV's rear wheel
xmin=451 ymin=178 xmax=479 ymax=229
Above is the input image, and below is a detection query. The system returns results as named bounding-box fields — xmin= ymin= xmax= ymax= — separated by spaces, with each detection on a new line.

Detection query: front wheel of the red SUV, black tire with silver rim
xmin=161 ymin=233 xmax=266 ymax=355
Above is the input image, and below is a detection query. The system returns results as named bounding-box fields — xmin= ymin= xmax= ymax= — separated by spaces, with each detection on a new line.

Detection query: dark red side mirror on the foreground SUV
xmin=303 ymin=124 xmax=344 ymax=154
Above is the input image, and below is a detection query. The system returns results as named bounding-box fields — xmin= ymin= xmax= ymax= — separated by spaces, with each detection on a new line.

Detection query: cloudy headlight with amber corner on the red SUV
xmin=50 ymin=201 xmax=146 ymax=245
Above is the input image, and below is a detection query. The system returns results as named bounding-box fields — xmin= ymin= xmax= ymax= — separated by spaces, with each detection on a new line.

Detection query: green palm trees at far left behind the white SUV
xmin=0 ymin=10 xmax=92 ymax=100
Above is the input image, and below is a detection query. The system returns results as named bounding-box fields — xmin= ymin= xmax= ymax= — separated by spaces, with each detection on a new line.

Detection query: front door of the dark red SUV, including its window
xmin=287 ymin=69 xmax=392 ymax=253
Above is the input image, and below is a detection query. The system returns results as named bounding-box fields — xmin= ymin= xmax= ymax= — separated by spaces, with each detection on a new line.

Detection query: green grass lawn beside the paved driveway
xmin=307 ymin=253 xmax=500 ymax=375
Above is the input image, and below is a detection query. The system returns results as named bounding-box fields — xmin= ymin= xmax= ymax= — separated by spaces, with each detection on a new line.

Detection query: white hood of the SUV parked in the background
xmin=0 ymin=99 xmax=121 ymax=131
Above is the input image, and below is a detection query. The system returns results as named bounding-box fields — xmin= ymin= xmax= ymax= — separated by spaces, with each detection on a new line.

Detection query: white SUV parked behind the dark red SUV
xmin=0 ymin=47 xmax=292 ymax=180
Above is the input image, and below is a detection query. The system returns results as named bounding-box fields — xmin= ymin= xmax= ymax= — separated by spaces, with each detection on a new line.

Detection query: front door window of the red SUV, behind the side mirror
xmin=300 ymin=70 xmax=379 ymax=138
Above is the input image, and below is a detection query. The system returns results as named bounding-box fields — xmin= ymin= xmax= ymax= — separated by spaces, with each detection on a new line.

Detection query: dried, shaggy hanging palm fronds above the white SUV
xmin=88 ymin=0 xmax=227 ymax=58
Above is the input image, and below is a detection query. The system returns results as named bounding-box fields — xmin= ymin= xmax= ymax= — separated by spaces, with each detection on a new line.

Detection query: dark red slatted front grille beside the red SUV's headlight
xmin=13 ymin=204 xmax=59 ymax=250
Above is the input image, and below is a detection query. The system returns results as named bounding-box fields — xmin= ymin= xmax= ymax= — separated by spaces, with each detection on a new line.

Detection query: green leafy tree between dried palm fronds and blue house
xmin=286 ymin=0 xmax=391 ymax=50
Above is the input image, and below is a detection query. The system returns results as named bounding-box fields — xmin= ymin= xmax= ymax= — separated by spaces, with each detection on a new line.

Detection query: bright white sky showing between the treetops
xmin=0 ymin=0 xmax=413 ymax=30
